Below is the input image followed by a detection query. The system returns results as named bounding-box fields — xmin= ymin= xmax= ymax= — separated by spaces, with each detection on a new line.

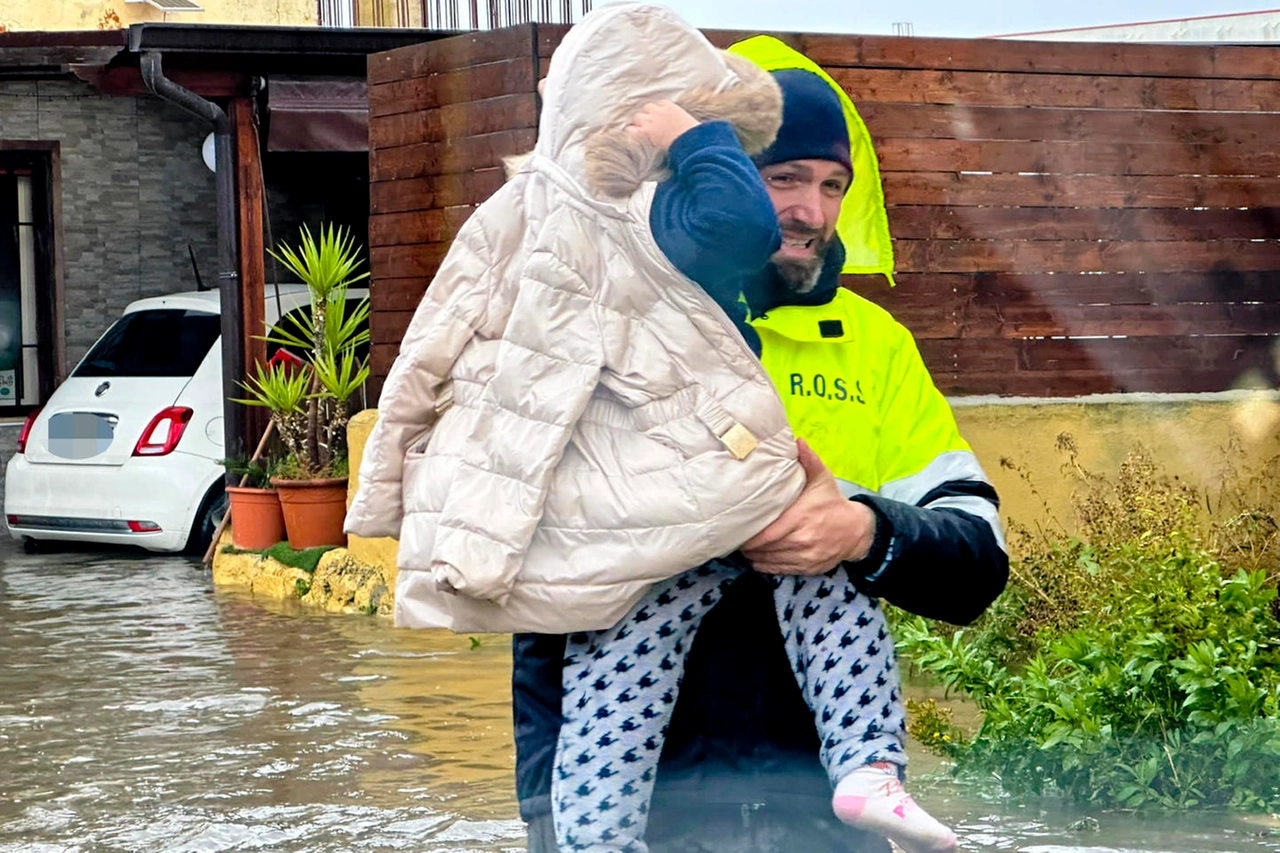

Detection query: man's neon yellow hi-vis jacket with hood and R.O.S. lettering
xmin=730 ymin=36 xmax=1006 ymax=578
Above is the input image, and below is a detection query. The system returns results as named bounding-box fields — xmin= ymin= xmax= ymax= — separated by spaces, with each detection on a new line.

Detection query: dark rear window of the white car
xmin=73 ymin=303 xmax=221 ymax=378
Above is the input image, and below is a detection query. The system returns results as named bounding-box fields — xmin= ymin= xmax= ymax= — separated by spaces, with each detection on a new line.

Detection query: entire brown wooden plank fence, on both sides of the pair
xmin=370 ymin=26 xmax=1280 ymax=397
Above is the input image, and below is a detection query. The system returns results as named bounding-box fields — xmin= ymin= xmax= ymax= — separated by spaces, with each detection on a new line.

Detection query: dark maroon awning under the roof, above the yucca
xmin=266 ymin=77 xmax=369 ymax=151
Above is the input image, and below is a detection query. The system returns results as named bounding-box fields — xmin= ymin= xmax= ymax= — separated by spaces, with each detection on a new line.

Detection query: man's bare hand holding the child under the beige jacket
xmin=742 ymin=441 xmax=876 ymax=575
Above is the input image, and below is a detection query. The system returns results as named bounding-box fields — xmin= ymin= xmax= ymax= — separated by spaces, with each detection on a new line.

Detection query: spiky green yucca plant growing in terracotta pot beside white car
xmin=239 ymin=224 xmax=369 ymax=479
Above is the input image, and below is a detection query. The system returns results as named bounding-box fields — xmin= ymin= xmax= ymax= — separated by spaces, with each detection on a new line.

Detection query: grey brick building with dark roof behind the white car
xmin=0 ymin=24 xmax=450 ymax=419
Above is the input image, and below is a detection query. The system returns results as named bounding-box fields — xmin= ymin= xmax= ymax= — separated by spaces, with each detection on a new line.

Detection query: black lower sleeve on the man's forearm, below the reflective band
xmin=845 ymin=482 xmax=1009 ymax=625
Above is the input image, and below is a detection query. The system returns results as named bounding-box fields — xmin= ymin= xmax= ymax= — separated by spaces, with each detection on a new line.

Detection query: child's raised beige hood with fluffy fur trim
xmin=535 ymin=3 xmax=782 ymax=200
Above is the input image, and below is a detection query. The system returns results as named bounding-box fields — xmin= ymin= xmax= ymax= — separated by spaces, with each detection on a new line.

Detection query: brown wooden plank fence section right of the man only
xmin=804 ymin=36 xmax=1280 ymax=396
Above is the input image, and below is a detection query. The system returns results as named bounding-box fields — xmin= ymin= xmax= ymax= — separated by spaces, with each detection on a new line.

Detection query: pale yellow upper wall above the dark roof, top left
xmin=0 ymin=0 xmax=319 ymax=31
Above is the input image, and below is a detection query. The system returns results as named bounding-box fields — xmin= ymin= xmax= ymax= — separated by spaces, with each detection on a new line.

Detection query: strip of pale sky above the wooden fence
xmin=645 ymin=0 xmax=1280 ymax=38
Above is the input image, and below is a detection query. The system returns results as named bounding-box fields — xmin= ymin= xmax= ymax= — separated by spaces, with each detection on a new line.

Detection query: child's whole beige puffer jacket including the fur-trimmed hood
xmin=346 ymin=4 xmax=804 ymax=633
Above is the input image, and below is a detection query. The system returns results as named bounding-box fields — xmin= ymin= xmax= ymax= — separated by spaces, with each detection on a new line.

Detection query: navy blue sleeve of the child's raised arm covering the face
xmin=649 ymin=122 xmax=782 ymax=351
